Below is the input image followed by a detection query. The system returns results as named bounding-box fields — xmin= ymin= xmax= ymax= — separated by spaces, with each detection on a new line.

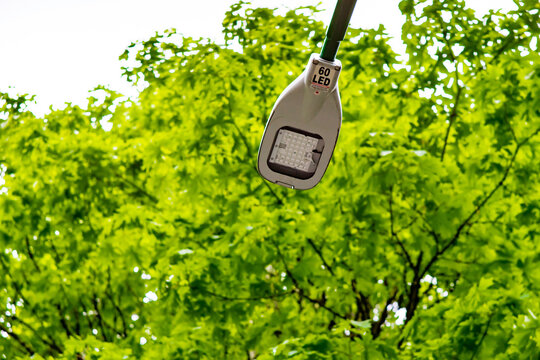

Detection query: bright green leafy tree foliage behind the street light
xmin=0 ymin=0 xmax=540 ymax=360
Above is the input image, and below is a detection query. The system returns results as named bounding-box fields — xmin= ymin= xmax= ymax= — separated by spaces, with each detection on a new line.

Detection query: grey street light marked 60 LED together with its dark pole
xmin=258 ymin=0 xmax=356 ymax=190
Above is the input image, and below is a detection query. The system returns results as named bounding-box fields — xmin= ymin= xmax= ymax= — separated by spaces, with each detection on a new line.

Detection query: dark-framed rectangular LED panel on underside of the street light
xmin=268 ymin=128 xmax=324 ymax=179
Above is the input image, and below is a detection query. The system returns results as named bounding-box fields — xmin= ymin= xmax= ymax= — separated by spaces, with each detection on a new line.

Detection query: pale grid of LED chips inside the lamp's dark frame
xmin=270 ymin=129 xmax=319 ymax=172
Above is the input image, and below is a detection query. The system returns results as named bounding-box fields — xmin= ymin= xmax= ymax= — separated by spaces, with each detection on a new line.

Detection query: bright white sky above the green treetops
xmin=0 ymin=0 xmax=515 ymax=115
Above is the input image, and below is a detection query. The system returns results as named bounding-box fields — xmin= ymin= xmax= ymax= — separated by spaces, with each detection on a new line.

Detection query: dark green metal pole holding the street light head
xmin=321 ymin=0 xmax=356 ymax=61
